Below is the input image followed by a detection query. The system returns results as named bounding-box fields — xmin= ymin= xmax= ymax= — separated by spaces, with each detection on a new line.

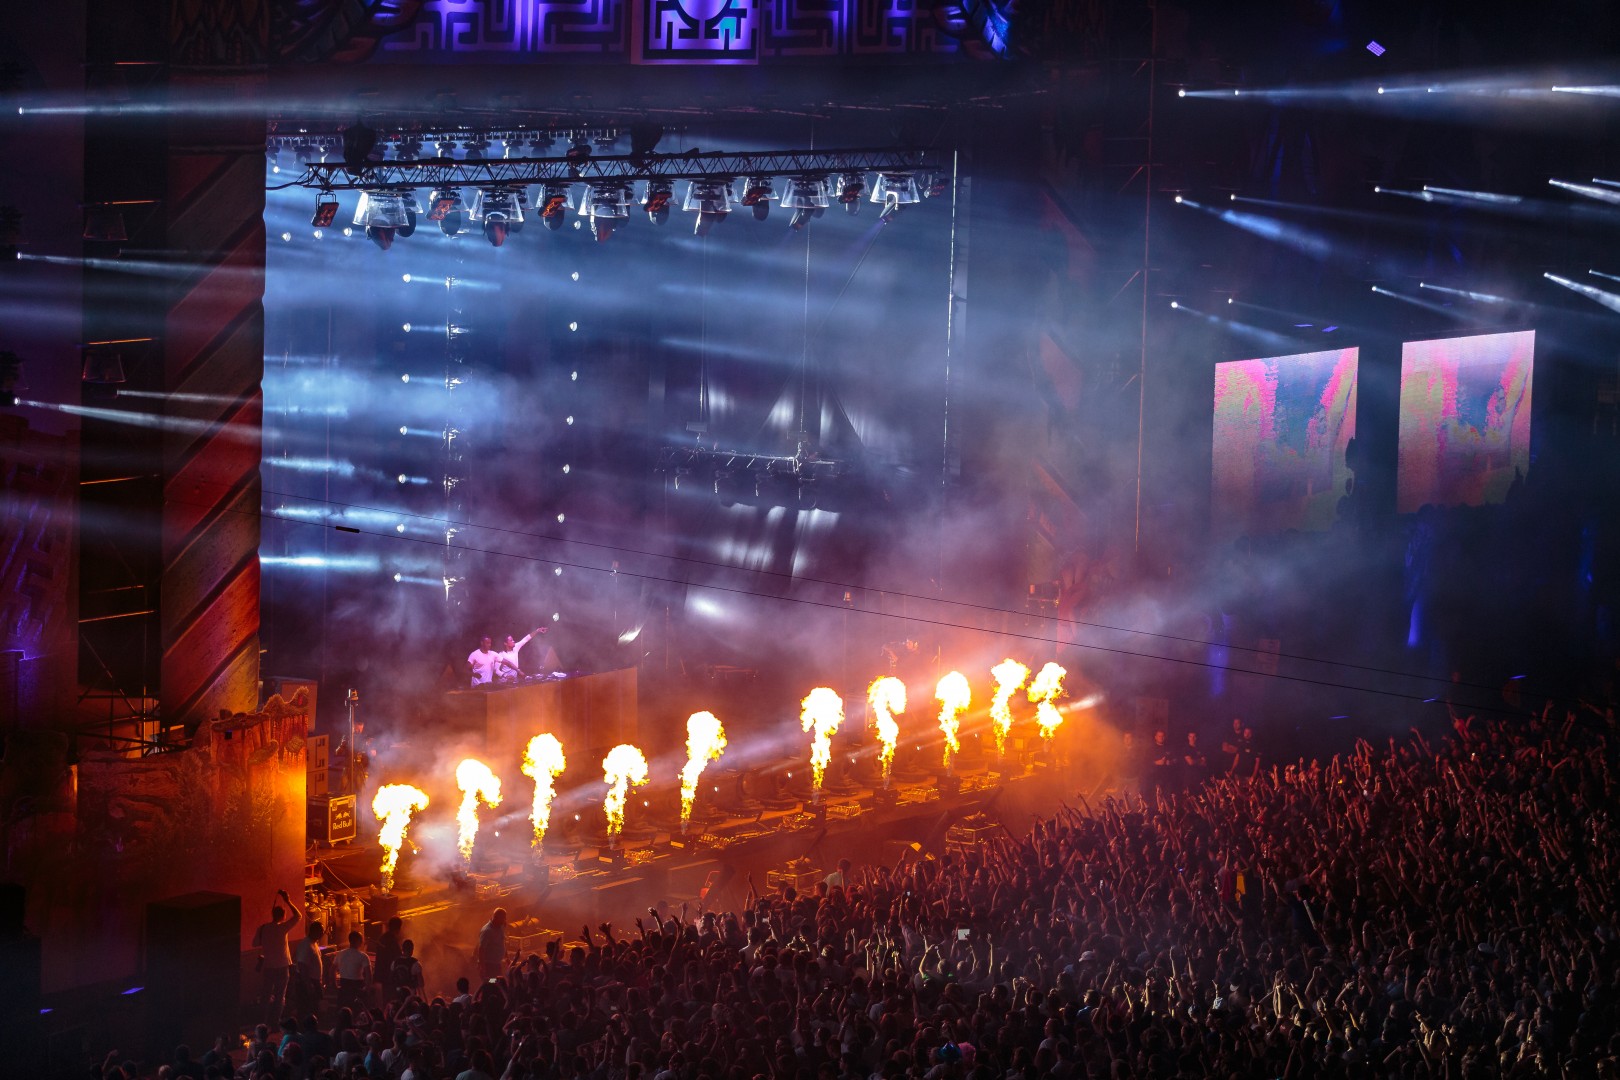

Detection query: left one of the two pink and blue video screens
xmin=1210 ymin=348 xmax=1359 ymax=539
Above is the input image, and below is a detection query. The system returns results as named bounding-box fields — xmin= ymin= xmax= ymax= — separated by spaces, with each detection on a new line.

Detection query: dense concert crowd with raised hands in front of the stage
xmin=99 ymin=693 xmax=1620 ymax=1080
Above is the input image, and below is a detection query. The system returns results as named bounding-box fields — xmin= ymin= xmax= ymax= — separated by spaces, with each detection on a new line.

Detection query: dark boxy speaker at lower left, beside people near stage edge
xmin=146 ymin=892 xmax=241 ymax=1051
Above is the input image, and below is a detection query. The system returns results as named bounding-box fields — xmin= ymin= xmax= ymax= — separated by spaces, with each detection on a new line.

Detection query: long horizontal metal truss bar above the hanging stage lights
xmin=292 ymin=149 xmax=944 ymax=191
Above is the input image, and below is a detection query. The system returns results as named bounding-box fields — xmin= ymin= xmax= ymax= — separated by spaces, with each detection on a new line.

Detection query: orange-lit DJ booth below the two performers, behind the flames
xmin=446 ymin=667 xmax=640 ymax=771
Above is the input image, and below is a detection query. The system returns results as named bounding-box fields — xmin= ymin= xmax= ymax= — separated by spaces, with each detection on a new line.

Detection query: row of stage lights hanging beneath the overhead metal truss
xmin=304 ymin=172 xmax=944 ymax=251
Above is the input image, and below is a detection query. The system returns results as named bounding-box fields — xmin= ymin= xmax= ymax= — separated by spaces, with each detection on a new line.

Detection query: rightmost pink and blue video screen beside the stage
xmin=1395 ymin=330 xmax=1536 ymax=513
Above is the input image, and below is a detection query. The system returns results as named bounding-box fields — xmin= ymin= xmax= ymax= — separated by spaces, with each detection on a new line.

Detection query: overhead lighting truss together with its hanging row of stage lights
xmin=272 ymin=145 xmax=948 ymax=248
